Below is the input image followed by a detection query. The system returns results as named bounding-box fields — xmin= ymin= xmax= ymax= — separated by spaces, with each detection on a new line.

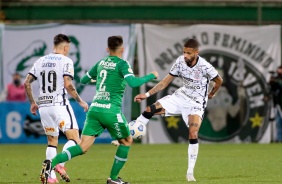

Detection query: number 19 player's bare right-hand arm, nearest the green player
xmin=64 ymin=75 xmax=88 ymax=111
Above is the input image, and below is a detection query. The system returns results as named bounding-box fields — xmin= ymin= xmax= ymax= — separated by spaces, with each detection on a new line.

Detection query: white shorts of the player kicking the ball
xmin=158 ymin=94 xmax=204 ymax=127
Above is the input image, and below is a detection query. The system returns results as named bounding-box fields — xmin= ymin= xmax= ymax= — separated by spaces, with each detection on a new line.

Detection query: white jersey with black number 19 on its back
xmin=29 ymin=53 xmax=74 ymax=107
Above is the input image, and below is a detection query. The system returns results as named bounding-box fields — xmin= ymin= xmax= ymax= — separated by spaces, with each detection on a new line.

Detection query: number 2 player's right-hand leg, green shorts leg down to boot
xmin=103 ymin=113 xmax=133 ymax=184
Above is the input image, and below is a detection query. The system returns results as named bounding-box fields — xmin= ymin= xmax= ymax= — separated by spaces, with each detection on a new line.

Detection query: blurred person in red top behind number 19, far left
xmin=0 ymin=73 xmax=26 ymax=102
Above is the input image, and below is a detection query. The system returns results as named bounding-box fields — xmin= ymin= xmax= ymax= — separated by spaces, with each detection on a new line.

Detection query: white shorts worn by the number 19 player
xmin=39 ymin=105 xmax=78 ymax=136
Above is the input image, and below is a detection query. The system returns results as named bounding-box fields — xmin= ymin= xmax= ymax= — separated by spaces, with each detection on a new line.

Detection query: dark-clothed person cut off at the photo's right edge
xmin=269 ymin=66 xmax=282 ymax=142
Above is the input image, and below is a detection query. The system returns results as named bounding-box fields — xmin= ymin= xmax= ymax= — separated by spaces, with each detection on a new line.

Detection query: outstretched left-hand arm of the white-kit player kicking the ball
xmin=134 ymin=74 xmax=175 ymax=103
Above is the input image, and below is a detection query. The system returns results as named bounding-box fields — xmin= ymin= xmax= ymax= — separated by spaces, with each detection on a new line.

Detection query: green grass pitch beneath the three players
xmin=0 ymin=144 xmax=282 ymax=184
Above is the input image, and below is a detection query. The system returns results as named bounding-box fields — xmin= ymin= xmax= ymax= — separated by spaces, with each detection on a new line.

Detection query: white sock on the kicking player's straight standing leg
xmin=187 ymin=143 xmax=199 ymax=174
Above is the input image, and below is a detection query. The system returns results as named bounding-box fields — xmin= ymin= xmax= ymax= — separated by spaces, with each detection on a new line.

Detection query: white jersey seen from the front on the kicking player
xmin=169 ymin=56 xmax=218 ymax=108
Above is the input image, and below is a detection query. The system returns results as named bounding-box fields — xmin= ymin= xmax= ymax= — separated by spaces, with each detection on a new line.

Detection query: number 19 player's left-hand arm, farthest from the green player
xmin=24 ymin=74 xmax=38 ymax=115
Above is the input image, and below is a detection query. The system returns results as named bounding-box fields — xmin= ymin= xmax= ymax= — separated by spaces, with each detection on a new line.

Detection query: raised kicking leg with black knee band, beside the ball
xmin=136 ymin=102 xmax=165 ymax=125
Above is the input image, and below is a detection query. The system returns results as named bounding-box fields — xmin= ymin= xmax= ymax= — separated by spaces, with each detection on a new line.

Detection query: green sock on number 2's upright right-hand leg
xmin=110 ymin=145 xmax=130 ymax=180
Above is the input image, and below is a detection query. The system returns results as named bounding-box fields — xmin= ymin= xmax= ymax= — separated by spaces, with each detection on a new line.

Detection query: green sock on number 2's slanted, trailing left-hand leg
xmin=52 ymin=144 xmax=83 ymax=168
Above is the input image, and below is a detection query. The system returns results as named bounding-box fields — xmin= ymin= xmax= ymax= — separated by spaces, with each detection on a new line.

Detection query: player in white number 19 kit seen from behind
xmin=24 ymin=34 xmax=88 ymax=183
